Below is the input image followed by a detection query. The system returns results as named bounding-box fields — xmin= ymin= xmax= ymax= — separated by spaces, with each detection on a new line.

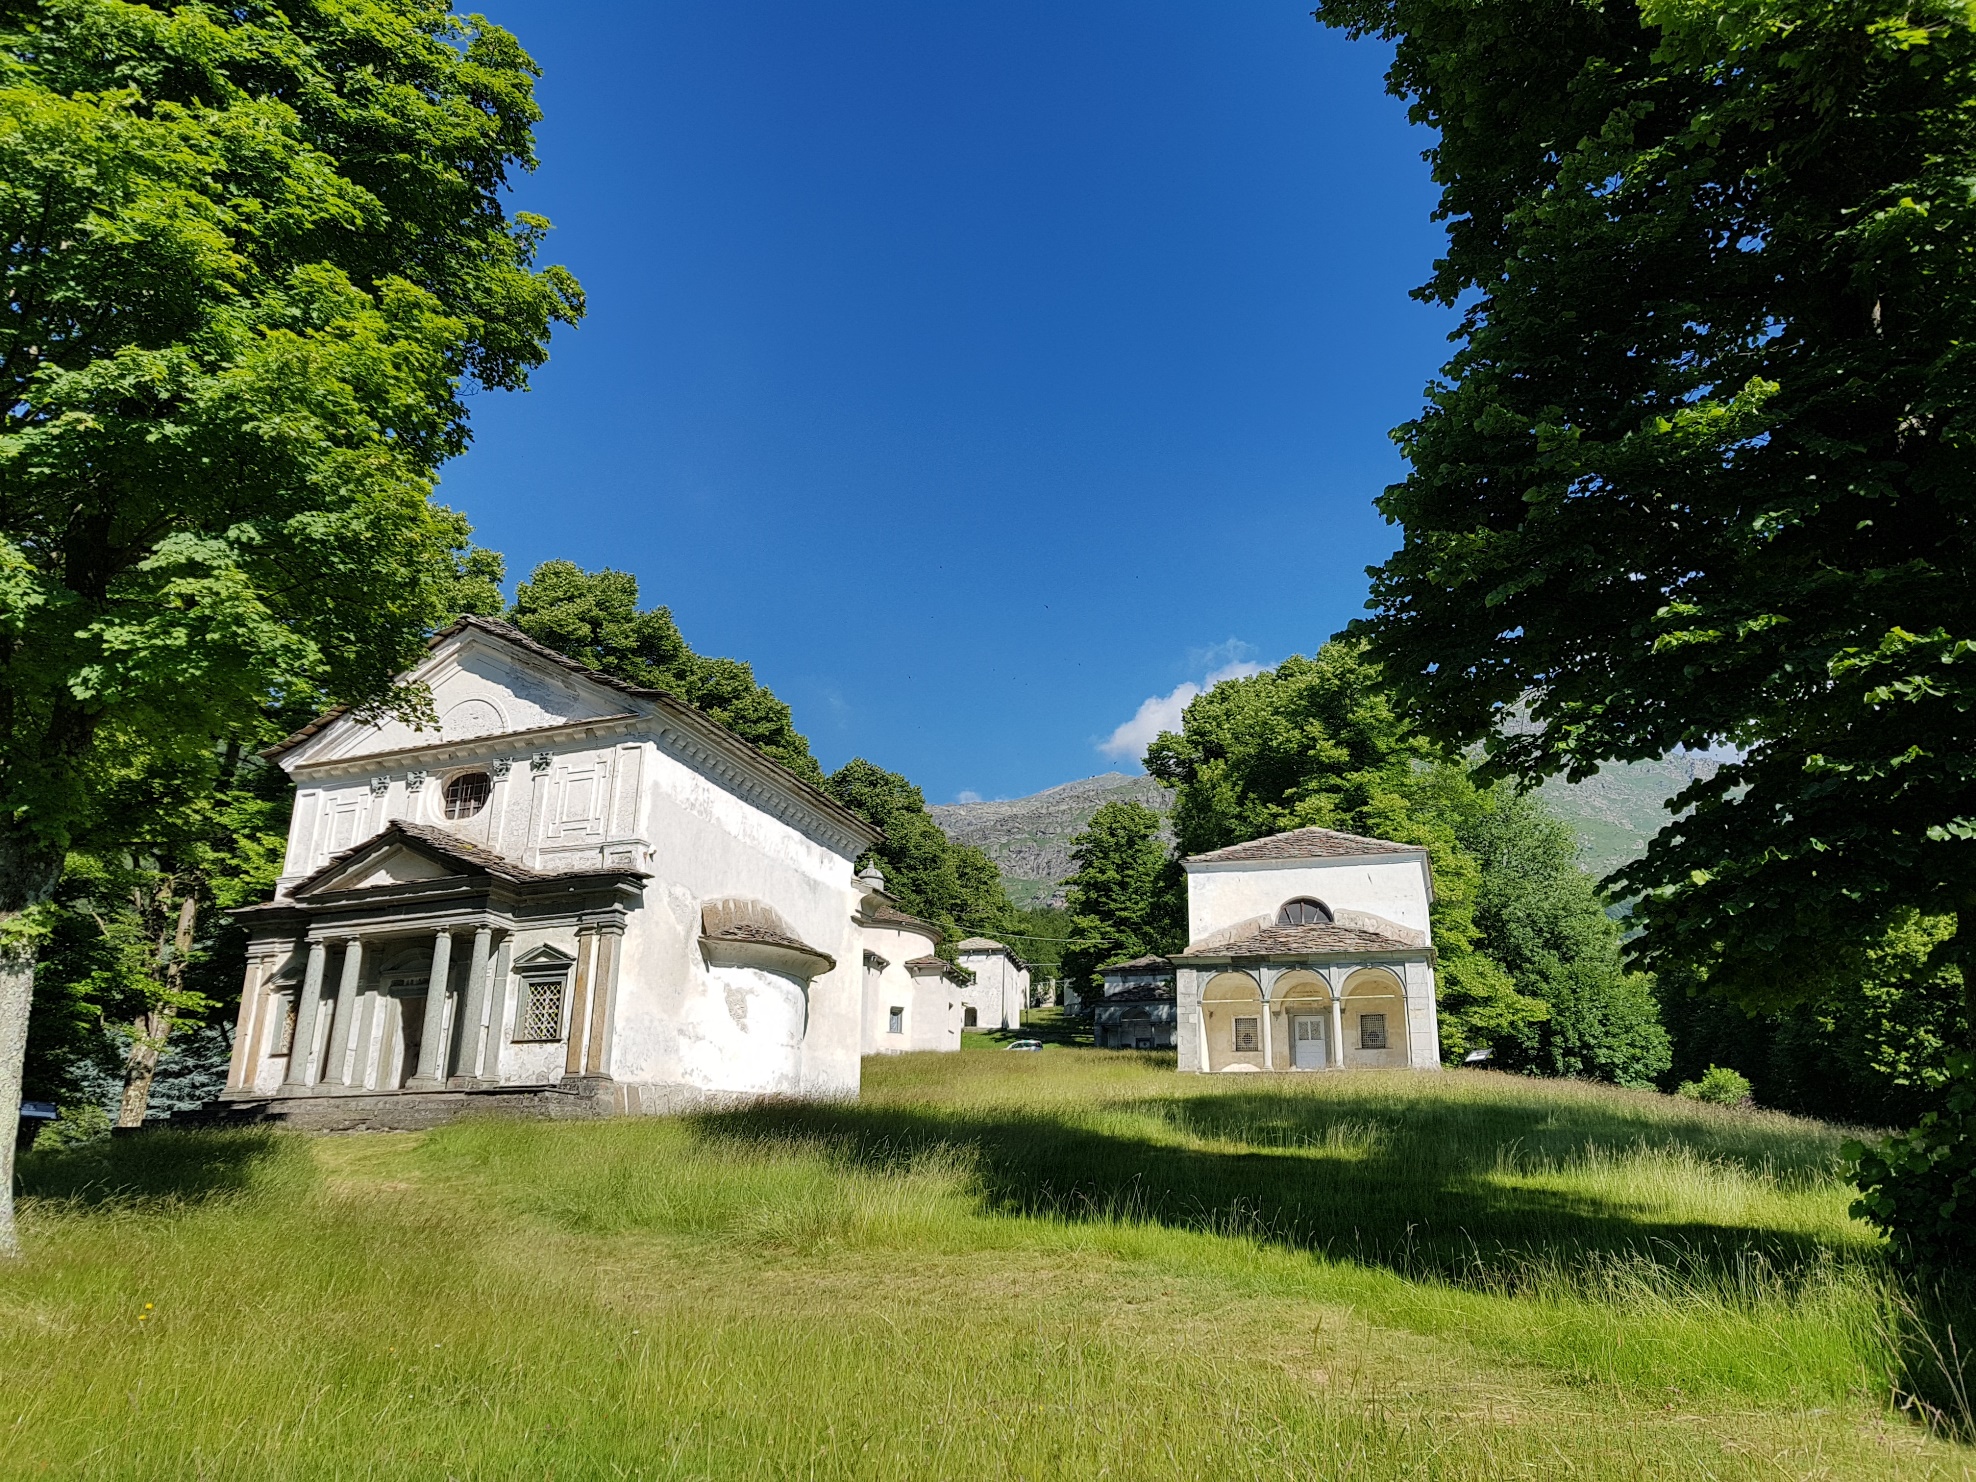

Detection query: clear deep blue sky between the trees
xmin=454 ymin=0 xmax=1450 ymax=802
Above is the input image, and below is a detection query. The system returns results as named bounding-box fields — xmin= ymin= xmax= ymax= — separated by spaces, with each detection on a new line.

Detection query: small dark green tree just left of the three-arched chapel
xmin=1063 ymin=802 xmax=1188 ymax=994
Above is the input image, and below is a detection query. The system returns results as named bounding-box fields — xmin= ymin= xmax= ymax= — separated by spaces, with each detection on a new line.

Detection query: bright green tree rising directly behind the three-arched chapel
xmin=1146 ymin=640 xmax=1549 ymax=1057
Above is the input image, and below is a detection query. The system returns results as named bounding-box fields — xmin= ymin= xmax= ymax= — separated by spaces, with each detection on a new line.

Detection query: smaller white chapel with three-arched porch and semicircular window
xmin=1170 ymin=828 xmax=1441 ymax=1071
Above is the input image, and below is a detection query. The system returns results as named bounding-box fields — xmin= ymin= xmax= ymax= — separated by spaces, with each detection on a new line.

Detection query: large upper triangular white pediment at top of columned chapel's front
xmin=287 ymin=626 xmax=638 ymax=765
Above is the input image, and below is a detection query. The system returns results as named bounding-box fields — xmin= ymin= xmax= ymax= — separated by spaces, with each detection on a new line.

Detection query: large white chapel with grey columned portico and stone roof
xmin=223 ymin=617 xmax=905 ymax=1126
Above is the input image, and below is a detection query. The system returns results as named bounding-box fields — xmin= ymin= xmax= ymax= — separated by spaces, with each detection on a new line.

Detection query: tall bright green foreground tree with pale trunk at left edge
xmin=0 ymin=0 xmax=581 ymax=1251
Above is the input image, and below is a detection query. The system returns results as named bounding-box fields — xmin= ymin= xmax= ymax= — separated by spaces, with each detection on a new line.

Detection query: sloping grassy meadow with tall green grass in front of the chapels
xmin=0 ymin=1035 xmax=1976 ymax=1480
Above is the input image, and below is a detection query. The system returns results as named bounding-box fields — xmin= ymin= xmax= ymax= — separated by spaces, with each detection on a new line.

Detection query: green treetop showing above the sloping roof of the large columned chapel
xmin=509 ymin=557 xmax=824 ymax=782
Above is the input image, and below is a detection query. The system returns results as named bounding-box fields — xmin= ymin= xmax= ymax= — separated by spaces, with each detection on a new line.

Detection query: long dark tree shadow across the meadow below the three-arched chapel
xmin=698 ymin=1087 xmax=1875 ymax=1290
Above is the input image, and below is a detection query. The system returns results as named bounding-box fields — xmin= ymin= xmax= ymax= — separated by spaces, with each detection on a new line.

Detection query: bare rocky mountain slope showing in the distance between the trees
xmin=929 ymin=755 xmax=1717 ymax=905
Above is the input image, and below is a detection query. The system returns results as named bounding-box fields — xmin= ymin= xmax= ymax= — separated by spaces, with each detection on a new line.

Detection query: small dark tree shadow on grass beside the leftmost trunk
xmin=16 ymin=1128 xmax=306 ymax=1205
